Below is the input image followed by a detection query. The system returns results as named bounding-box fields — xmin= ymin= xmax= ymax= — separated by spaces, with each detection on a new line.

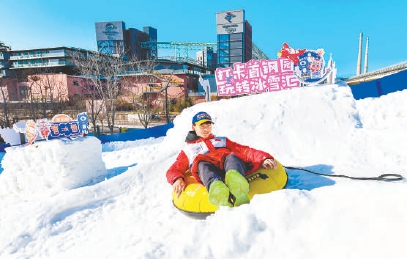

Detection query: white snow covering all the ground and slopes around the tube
xmin=0 ymin=85 xmax=407 ymax=259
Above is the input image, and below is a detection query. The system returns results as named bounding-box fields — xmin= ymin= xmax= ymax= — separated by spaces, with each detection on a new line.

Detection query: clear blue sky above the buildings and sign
xmin=0 ymin=0 xmax=407 ymax=76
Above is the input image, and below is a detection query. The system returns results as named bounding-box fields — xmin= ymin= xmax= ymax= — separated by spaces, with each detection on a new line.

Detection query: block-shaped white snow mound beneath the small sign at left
xmin=0 ymin=137 xmax=107 ymax=197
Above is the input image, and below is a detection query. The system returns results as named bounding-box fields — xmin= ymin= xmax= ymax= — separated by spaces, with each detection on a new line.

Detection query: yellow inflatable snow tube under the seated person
xmin=172 ymin=161 xmax=288 ymax=219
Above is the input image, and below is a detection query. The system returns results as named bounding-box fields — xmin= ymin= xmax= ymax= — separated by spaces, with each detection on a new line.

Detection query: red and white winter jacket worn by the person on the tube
xmin=167 ymin=131 xmax=274 ymax=184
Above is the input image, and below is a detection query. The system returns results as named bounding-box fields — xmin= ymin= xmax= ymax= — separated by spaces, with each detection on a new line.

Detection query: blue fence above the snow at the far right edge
xmin=350 ymin=70 xmax=407 ymax=100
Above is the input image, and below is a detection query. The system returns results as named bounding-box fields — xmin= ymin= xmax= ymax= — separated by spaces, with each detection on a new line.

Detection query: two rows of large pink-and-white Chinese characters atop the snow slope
xmin=215 ymin=58 xmax=301 ymax=96
